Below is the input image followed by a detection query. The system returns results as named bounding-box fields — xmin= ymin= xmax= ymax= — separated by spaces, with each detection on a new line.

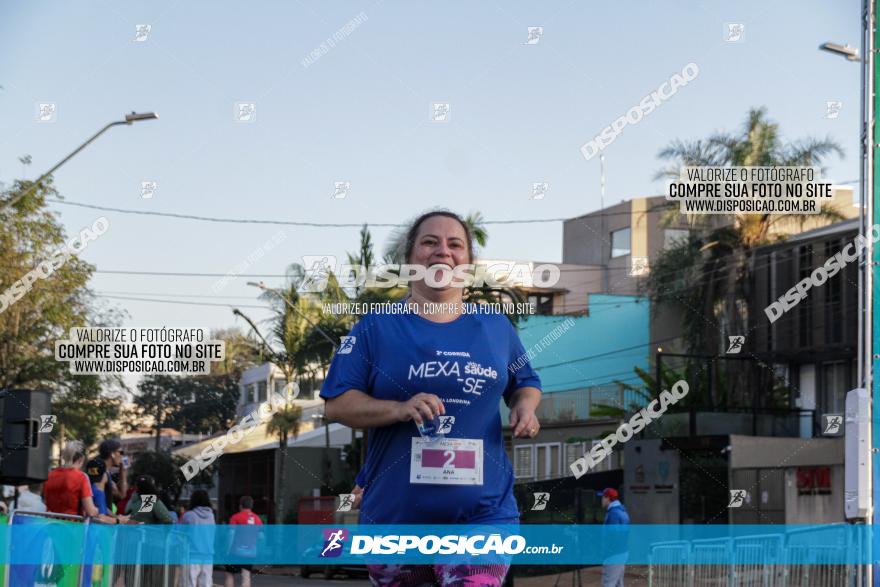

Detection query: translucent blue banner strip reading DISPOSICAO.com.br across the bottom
xmin=0 ymin=517 xmax=880 ymax=565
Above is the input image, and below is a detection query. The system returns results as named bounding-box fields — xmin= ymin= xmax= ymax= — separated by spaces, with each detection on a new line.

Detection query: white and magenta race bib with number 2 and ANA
xmin=409 ymin=437 xmax=483 ymax=485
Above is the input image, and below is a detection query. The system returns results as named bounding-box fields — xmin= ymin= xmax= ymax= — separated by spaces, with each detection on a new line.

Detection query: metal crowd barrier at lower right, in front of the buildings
xmin=648 ymin=524 xmax=863 ymax=587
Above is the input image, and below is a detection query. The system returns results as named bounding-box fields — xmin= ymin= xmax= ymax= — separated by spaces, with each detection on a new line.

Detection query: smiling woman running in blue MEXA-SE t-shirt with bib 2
xmin=321 ymin=211 xmax=541 ymax=586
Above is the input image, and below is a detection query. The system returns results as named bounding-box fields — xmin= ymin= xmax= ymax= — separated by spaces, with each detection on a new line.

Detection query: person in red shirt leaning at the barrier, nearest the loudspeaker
xmin=43 ymin=440 xmax=128 ymax=524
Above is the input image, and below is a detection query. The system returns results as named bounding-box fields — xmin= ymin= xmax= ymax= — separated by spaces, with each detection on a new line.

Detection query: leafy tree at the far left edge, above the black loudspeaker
xmin=0 ymin=178 xmax=124 ymax=442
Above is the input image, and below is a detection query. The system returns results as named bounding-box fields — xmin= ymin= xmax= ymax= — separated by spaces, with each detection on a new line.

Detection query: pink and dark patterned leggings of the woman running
xmin=367 ymin=565 xmax=509 ymax=587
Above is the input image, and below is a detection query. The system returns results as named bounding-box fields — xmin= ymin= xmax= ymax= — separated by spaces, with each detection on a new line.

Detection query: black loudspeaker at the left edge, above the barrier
xmin=0 ymin=389 xmax=55 ymax=485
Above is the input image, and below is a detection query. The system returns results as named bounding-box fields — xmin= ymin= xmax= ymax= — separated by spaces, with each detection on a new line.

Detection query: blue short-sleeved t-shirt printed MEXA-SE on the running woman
xmin=321 ymin=306 xmax=541 ymax=524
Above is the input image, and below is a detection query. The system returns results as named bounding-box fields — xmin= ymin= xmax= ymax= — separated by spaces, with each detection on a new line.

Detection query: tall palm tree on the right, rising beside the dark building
xmin=645 ymin=108 xmax=843 ymax=400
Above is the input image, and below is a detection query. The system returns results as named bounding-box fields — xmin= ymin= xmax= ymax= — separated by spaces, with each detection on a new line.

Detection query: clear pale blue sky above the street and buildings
xmin=0 ymin=0 xmax=859 ymax=338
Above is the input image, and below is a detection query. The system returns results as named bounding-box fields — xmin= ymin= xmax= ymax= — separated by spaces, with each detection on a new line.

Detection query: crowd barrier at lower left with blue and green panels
xmin=0 ymin=511 xmax=190 ymax=587
